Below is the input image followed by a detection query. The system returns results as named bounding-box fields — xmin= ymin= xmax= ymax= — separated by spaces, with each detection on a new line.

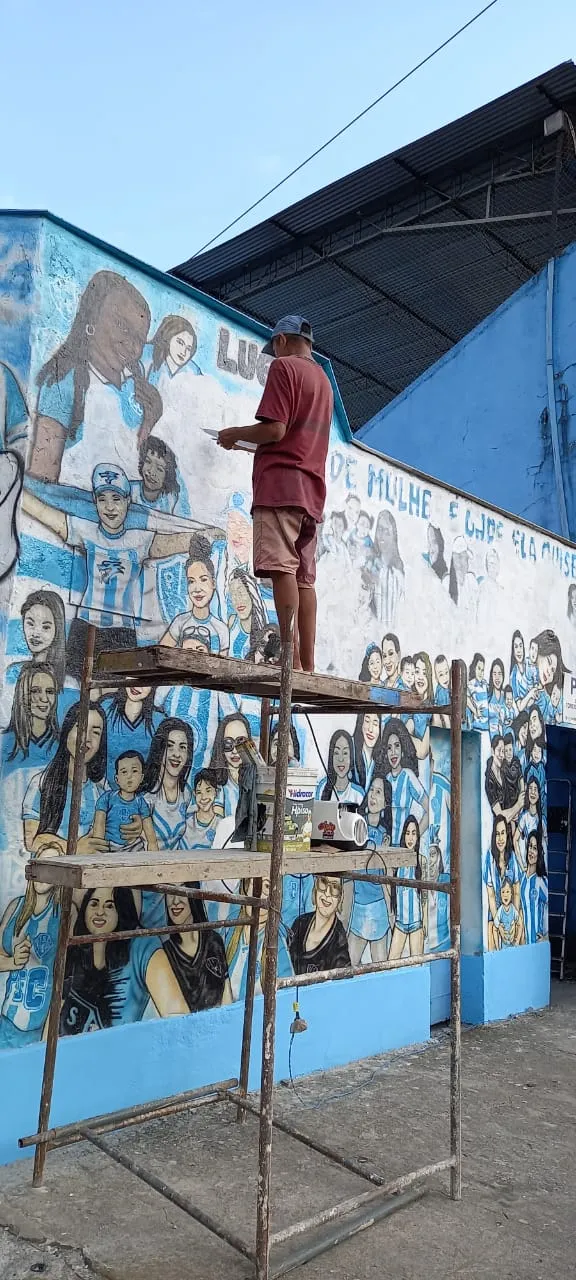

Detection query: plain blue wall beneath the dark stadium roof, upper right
xmin=358 ymin=244 xmax=576 ymax=538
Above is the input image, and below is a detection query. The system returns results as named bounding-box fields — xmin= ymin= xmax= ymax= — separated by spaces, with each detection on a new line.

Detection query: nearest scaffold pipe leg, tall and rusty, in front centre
xmin=256 ymin=609 xmax=294 ymax=1280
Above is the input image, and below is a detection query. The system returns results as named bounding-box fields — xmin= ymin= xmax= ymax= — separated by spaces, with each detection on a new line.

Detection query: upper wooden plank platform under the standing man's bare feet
xmin=92 ymin=645 xmax=437 ymax=714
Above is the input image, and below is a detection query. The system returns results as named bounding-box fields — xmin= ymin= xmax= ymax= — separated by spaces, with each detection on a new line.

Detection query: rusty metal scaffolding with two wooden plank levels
xmin=19 ymin=614 xmax=465 ymax=1280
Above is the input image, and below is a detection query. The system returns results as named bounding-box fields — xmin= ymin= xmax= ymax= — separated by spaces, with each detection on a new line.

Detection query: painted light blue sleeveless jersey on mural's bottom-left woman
xmin=0 ymin=897 xmax=59 ymax=1048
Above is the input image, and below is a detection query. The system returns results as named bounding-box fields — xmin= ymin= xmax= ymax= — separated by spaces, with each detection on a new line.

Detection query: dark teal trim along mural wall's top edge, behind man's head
xmin=0 ymin=209 xmax=353 ymax=442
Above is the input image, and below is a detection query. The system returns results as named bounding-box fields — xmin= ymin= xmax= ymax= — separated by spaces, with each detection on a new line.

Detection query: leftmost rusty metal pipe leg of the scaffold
xmin=32 ymin=626 xmax=96 ymax=1187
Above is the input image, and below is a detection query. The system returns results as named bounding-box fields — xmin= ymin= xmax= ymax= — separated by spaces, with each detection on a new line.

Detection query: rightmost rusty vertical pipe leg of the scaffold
xmin=451 ymin=660 xmax=465 ymax=1201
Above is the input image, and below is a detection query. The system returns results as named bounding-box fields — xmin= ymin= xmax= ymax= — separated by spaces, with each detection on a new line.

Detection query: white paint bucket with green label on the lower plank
xmin=256 ymin=767 xmax=317 ymax=854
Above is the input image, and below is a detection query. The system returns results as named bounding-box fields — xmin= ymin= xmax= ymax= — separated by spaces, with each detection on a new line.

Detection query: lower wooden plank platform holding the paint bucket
xmin=26 ymin=846 xmax=416 ymax=888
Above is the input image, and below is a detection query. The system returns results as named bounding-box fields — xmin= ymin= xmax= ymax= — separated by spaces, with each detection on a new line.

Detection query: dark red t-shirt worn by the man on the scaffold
xmin=252 ymin=356 xmax=334 ymax=520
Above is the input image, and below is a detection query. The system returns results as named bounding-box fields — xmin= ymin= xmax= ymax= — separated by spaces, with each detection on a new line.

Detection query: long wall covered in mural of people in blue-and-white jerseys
xmin=0 ymin=215 xmax=568 ymax=1160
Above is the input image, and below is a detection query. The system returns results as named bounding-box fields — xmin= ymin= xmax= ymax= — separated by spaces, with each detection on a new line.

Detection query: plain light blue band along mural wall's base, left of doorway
xmin=0 ymin=966 xmax=430 ymax=1164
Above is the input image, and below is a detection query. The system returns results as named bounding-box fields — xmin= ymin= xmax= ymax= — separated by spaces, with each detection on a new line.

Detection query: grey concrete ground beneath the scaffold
xmin=0 ymin=983 xmax=576 ymax=1280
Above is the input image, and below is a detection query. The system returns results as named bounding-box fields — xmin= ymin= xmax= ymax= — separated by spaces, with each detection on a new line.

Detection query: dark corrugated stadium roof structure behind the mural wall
xmin=172 ymin=61 xmax=576 ymax=429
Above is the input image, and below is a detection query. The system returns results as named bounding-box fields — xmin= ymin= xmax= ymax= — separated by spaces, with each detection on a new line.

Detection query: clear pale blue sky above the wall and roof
xmin=0 ymin=0 xmax=576 ymax=268
